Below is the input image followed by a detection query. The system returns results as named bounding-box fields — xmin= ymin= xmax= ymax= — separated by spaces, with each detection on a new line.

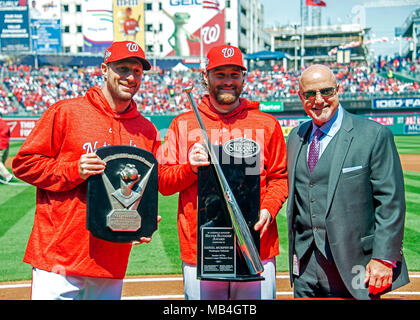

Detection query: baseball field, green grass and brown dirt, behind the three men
xmin=0 ymin=135 xmax=420 ymax=300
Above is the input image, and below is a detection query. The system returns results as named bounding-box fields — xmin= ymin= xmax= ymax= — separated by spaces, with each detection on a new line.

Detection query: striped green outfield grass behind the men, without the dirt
xmin=0 ymin=136 xmax=420 ymax=281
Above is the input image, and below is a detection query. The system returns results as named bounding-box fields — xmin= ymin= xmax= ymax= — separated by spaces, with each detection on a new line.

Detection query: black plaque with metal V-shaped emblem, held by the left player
xmin=87 ymin=145 xmax=158 ymax=242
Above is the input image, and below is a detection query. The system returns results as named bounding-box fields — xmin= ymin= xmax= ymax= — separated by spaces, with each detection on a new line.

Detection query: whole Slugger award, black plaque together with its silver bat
xmin=184 ymin=88 xmax=264 ymax=281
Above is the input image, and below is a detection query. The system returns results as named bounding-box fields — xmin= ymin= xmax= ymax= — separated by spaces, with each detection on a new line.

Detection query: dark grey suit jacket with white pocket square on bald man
xmin=287 ymin=110 xmax=409 ymax=299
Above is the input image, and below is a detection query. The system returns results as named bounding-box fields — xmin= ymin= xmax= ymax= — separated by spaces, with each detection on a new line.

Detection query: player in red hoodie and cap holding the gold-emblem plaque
xmin=13 ymin=41 xmax=160 ymax=299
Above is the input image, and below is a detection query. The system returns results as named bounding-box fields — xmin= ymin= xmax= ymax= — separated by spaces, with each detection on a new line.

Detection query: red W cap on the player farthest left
xmin=104 ymin=41 xmax=152 ymax=70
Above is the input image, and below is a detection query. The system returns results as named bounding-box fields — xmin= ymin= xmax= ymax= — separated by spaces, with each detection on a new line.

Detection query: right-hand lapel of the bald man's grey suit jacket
xmin=326 ymin=110 xmax=353 ymax=216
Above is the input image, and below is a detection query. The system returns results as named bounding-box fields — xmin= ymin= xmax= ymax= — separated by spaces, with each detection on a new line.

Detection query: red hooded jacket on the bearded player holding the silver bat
xmin=159 ymin=95 xmax=288 ymax=265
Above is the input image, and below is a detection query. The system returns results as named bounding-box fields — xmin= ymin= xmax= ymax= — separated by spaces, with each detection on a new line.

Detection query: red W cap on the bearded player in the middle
xmin=206 ymin=45 xmax=246 ymax=71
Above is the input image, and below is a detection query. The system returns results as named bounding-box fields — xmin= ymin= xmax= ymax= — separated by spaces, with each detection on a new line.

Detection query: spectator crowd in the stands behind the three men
xmin=0 ymin=58 xmax=420 ymax=115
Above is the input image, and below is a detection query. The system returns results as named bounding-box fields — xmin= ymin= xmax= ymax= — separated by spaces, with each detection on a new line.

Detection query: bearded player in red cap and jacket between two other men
xmin=159 ymin=45 xmax=288 ymax=299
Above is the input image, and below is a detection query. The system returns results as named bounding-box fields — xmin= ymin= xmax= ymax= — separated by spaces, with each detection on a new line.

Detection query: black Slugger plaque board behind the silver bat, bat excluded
xmin=197 ymin=138 xmax=263 ymax=281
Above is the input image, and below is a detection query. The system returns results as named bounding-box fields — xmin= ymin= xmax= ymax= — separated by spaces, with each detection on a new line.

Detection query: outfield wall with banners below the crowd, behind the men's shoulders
xmin=3 ymin=112 xmax=420 ymax=140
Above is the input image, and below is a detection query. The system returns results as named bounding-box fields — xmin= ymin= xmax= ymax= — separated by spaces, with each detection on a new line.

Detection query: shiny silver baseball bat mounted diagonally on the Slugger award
xmin=184 ymin=87 xmax=264 ymax=275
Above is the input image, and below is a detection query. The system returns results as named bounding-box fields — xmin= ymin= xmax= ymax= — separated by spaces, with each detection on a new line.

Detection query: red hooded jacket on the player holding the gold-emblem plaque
xmin=13 ymin=87 xmax=161 ymax=279
